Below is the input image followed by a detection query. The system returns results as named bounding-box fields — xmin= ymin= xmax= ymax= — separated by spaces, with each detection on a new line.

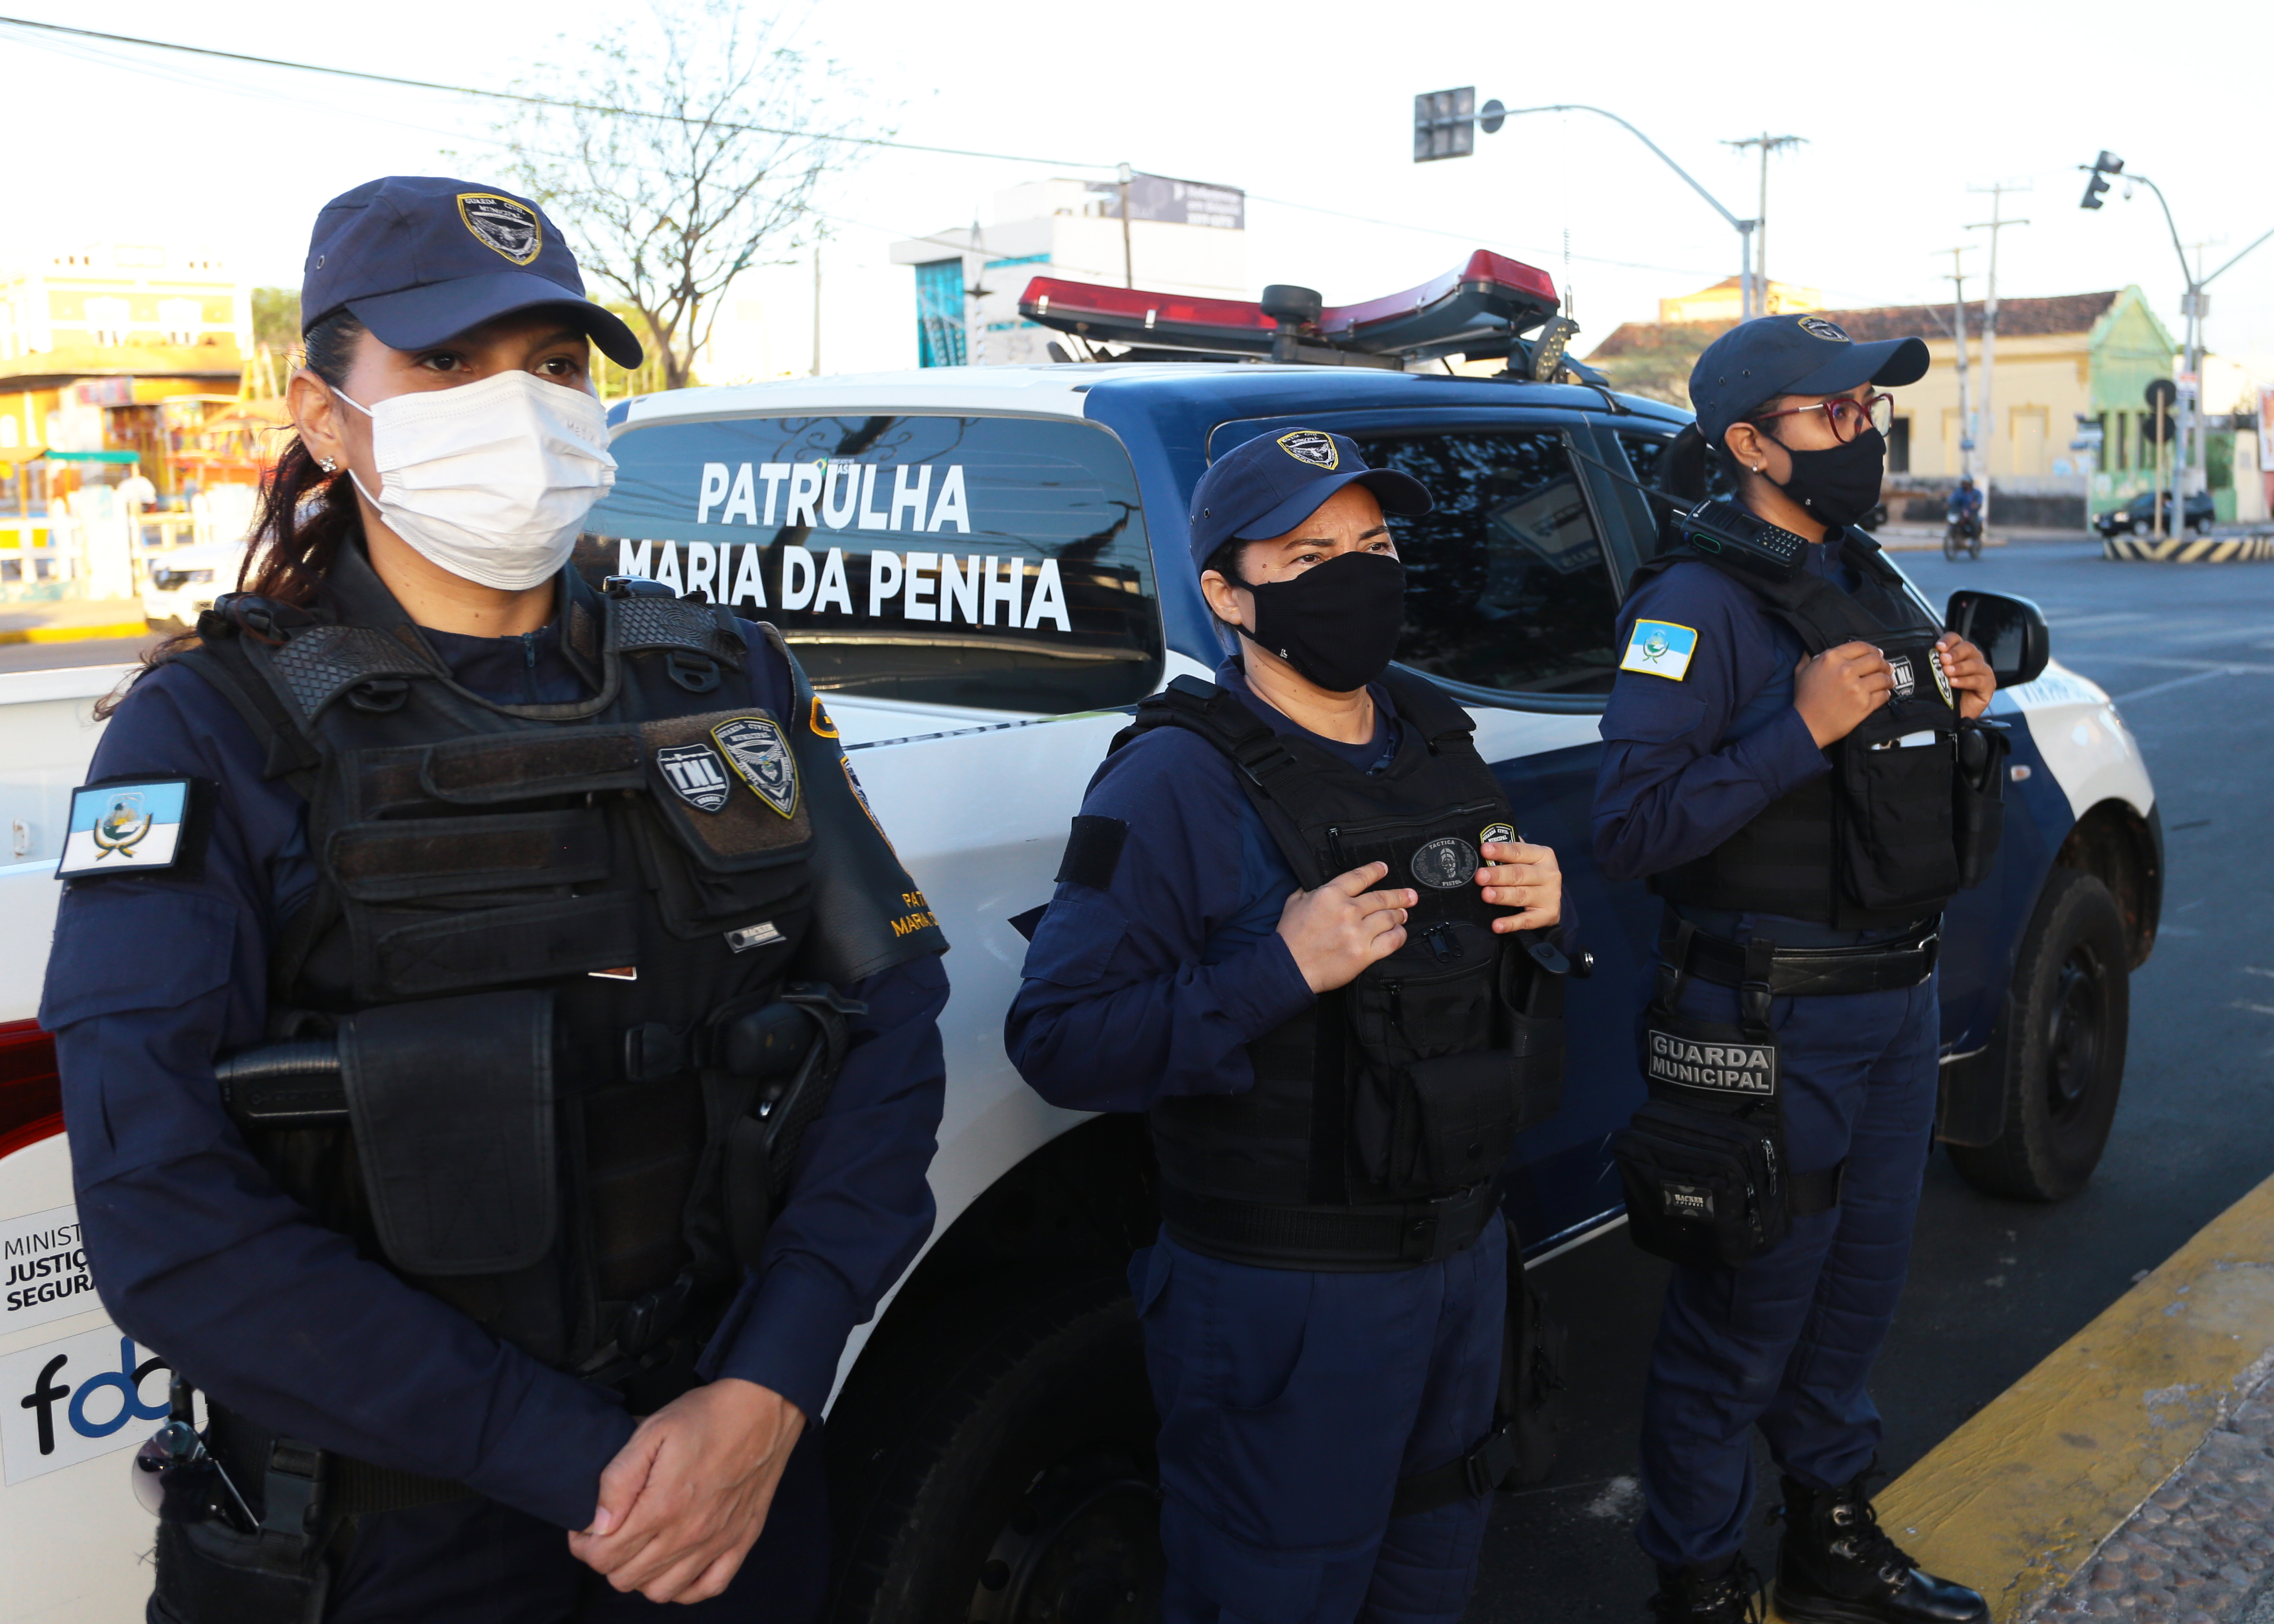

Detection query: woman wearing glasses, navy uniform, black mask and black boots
xmin=1594 ymin=316 xmax=1994 ymax=1624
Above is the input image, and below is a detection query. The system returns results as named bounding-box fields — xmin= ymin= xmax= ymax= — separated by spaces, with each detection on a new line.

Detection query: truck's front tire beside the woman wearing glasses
xmin=1951 ymin=869 xmax=2131 ymax=1201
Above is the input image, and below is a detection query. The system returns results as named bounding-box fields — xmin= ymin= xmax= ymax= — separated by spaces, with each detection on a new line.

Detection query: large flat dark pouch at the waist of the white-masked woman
xmin=339 ymin=992 xmax=560 ymax=1276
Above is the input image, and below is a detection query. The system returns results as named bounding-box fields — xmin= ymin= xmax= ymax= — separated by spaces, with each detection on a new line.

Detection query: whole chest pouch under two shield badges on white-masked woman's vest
xmin=639 ymin=707 xmax=814 ymax=941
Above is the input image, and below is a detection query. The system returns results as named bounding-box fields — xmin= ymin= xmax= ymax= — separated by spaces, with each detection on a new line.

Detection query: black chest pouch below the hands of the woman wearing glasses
xmin=1833 ymin=646 xmax=1958 ymax=912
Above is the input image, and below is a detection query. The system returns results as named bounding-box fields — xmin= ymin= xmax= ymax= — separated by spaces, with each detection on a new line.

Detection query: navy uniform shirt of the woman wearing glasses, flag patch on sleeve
xmin=1594 ymin=530 xmax=1858 ymax=941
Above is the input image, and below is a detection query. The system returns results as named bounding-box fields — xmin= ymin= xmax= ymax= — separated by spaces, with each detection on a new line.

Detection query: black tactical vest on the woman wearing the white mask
xmin=184 ymin=546 xmax=946 ymax=1380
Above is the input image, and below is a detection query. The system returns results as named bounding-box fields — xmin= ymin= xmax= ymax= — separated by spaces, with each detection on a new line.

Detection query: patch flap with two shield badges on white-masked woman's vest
xmin=639 ymin=710 xmax=814 ymax=873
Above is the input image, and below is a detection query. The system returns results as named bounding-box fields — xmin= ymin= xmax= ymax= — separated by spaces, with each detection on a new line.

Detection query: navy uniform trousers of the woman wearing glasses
xmin=1639 ymin=960 xmax=1940 ymax=1567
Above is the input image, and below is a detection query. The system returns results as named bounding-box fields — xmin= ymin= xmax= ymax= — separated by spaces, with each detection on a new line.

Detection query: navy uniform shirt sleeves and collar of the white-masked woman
xmin=41 ymin=628 xmax=948 ymax=1529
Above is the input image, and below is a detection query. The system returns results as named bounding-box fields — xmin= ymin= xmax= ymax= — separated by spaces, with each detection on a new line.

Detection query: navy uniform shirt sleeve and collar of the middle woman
xmin=1003 ymin=662 xmax=1401 ymax=1110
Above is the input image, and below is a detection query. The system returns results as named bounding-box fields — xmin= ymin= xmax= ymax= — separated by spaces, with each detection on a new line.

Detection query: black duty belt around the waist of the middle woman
xmin=1160 ymin=1178 xmax=1501 ymax=1274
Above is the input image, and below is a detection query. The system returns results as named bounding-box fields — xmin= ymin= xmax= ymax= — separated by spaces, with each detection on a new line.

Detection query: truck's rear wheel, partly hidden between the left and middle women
xmin=832 ymin=1276 xmax=1162 ymax=1624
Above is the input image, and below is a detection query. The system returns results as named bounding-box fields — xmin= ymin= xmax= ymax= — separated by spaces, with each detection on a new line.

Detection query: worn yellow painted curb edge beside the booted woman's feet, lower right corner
xmin=1878 ymin=1178 xmax=2274 ymax=1624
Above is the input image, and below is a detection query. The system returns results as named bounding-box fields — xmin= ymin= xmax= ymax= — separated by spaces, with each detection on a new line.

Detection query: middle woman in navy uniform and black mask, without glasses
xmin=1005 ymin=430 xmax=1562 ymax=1624
